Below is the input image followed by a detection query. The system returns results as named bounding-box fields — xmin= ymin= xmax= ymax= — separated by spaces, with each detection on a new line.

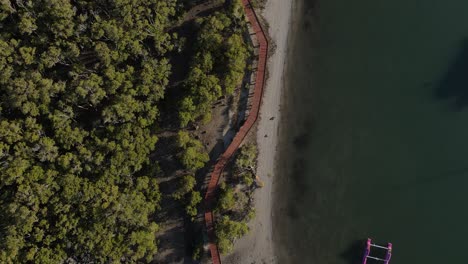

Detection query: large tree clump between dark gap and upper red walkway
xmin=179 ymin=1 xmax=249 ymax=127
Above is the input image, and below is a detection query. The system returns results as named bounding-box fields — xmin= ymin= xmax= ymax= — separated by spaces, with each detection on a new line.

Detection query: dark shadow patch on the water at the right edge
xmin=435 ymin=39 xmax=468 ymax=111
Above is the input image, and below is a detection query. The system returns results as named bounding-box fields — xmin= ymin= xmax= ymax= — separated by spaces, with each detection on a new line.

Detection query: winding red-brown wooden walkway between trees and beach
xmin=205 ymin=0 xmax=268 ymax=264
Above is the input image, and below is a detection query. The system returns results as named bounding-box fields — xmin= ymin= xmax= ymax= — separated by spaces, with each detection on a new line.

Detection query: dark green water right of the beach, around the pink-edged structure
xmin=274 ymin=0 xmax=468 ymax=264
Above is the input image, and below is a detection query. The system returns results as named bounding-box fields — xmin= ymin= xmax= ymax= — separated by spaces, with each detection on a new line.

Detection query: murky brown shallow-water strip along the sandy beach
xmin=272 ymin=0 xmax=318 ymax=263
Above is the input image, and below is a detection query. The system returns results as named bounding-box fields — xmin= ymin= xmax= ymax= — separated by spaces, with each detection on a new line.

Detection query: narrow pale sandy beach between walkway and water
xmin=223 ymin=0 xmax=293 ymax=264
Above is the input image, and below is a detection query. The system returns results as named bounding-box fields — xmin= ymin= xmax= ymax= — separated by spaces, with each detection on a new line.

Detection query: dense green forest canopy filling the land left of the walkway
xmin=0 ymin=0 xmax=249 ymax=263
